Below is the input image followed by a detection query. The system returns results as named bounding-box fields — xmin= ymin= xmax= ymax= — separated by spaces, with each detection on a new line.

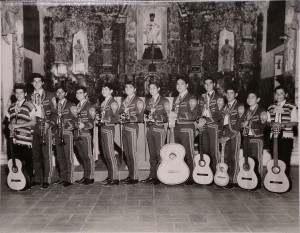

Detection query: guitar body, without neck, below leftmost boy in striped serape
xmin=7 ymin=159 xmax=27 ymax=191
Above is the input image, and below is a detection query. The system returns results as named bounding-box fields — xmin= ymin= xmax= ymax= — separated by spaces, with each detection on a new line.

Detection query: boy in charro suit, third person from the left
xmin=49 ymin=85 xmax=77 ymax=187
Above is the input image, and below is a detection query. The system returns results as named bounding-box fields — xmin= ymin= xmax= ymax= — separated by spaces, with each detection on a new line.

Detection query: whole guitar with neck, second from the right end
xmin=237 ymin=127 xmax=258 ymax=189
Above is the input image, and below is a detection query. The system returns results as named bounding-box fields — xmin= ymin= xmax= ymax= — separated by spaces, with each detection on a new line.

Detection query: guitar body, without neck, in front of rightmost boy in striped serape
xmin=264 ymin=159 xmax=290 ymax=193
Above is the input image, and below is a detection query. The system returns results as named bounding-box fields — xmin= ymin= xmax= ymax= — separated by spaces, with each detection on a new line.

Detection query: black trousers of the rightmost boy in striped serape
xmin=271 ymin=135 xmax=294 ymax=177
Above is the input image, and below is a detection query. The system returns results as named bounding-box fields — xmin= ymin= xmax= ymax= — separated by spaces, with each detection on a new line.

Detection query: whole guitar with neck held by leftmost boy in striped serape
xmin=7 ymin=120 xmax=28 ymax=191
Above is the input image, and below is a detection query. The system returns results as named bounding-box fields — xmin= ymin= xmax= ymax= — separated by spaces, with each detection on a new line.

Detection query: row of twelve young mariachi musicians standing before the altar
xmin=8 ymin=73 xmax=298 ymax=192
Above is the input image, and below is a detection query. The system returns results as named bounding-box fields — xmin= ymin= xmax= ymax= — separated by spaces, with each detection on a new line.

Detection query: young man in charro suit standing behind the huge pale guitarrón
xmin=172 ymin=77 xmax=198 ymax=185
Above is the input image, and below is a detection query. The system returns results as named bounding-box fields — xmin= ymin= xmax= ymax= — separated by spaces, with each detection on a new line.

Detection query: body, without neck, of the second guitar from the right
xmin=237 ymin=157 xmax=258 ymax=189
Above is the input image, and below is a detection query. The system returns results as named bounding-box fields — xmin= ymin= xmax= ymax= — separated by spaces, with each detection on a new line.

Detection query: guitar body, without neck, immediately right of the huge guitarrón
xmin=193 ymin=154 xmax=214 ymax=185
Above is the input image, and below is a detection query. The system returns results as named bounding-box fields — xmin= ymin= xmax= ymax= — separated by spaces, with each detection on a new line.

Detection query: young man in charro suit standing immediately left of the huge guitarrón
xmin=142 ymin=82 xmax=170 ymax=185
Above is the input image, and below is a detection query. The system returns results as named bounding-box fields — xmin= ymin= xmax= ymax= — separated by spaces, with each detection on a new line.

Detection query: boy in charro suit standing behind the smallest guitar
xmin=220 ymin=87 xmax=245 ymax=188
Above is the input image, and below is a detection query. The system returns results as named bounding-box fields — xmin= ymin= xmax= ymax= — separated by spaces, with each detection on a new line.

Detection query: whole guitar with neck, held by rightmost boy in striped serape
xmin=264 ymin=126 xmax=290 ymax=193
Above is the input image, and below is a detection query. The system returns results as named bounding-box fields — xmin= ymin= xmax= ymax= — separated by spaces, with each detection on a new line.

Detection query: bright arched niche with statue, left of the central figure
xmin=73 ymin=30 xmax=89 ymax=74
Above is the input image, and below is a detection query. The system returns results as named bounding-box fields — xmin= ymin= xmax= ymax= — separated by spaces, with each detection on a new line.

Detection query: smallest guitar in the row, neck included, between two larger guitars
xmin=214 ymin=139 xmax=229 ymax=187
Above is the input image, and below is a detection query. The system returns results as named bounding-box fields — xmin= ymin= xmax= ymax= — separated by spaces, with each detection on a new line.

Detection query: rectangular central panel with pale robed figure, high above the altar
xmin=137 ymin=6 xmax=167 ymax=61
